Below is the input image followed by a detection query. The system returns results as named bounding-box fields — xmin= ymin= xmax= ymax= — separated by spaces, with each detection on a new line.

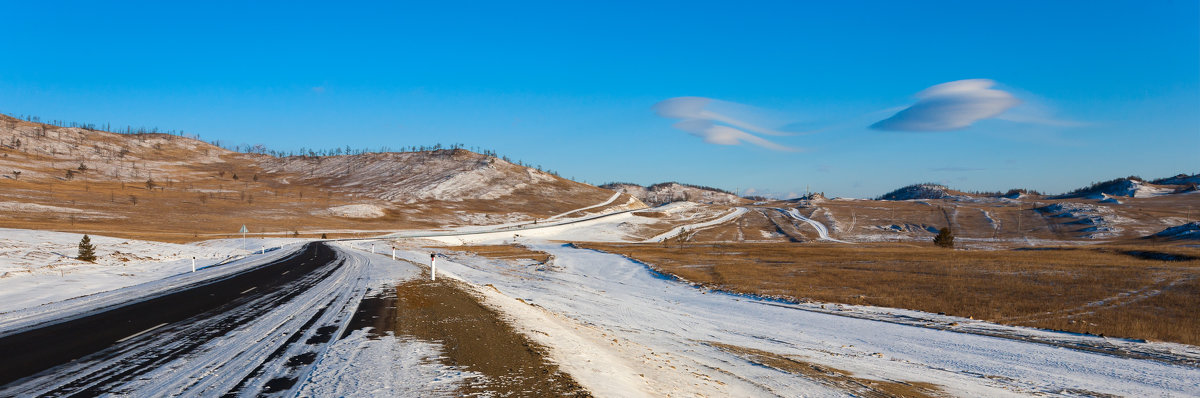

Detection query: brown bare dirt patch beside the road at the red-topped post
xmin=350 ymin=275 xmax=590 ymax=397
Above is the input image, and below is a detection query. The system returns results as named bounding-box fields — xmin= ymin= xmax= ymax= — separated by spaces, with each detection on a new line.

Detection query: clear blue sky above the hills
xmin=0 ymin=1 xmax=1200 ymax=197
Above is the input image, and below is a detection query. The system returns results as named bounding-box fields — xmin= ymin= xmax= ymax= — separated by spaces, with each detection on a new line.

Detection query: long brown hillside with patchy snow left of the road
xmin=0 ymin=115 xmax=625 ymax=241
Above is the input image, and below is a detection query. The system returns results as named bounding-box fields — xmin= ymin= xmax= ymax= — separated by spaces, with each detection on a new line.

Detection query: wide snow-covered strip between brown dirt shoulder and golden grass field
xmin=388 ymin=243 xmax=1200 ymax=397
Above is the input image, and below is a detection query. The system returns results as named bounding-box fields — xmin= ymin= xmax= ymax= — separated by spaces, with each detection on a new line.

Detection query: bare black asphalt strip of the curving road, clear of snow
xmin=0 ymin=242 xmax=336 ymax=386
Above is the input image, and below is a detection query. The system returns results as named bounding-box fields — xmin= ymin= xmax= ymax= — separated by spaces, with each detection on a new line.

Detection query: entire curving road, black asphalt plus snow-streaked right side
xmin=0 ymin=242 xmax=367 ymax=396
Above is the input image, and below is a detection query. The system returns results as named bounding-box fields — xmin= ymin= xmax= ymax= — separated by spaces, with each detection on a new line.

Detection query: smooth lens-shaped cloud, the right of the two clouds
xmin=871 ymin=79 xmax=1021 ymax=132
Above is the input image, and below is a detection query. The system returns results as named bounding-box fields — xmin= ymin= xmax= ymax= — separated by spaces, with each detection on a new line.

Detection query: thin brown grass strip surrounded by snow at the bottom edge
xmin=704 ymin=342 xmax=944 ymax=398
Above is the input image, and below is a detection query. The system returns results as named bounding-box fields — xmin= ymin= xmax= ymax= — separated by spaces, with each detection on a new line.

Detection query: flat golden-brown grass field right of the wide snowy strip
xmin=583 ymin=243 xmax=1200 ymax=344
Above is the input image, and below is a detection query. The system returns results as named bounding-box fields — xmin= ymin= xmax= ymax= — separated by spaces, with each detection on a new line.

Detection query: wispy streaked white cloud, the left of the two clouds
xmin=652 ymin=97 xmax=798 ymax=151
